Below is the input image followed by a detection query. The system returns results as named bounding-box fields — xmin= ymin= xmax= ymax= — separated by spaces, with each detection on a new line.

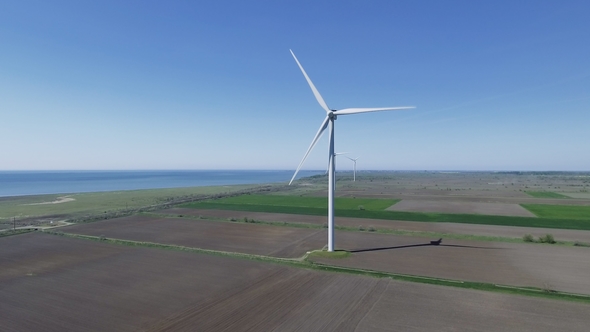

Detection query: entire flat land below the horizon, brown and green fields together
xmin=0 ymin=172 xmax=590 ymax=331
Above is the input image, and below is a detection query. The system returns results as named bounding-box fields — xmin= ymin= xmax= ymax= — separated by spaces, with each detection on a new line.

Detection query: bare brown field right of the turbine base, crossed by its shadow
xmin=313 ymin=231 xmax=590 ymax=295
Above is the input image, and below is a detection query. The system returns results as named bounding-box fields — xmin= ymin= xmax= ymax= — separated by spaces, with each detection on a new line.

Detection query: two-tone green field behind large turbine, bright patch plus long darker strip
xmin=182 ymin=195 xmax=590 ymax=230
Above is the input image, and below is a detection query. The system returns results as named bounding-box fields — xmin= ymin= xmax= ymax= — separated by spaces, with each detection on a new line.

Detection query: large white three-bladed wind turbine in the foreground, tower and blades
xmin=289 ymin=50 xmax=414 ymax=251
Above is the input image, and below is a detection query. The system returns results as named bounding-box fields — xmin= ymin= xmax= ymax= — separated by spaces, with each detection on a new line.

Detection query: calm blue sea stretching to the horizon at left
xmin=0 ymin=170 xmax=322 ymax=197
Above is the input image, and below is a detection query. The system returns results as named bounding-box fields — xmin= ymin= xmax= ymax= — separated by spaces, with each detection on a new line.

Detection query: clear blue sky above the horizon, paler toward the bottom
xmin=0 ymin=0 xmax=590 ymax=170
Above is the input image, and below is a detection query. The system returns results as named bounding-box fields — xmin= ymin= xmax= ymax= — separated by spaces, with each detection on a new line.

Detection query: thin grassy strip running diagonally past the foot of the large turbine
xmin=44 ymin=231 xmax=590 ymax=304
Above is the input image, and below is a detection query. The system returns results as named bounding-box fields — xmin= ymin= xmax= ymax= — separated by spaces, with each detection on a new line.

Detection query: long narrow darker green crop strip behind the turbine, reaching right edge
xmin=180 ymin=200 xmax=590 ymax=230
